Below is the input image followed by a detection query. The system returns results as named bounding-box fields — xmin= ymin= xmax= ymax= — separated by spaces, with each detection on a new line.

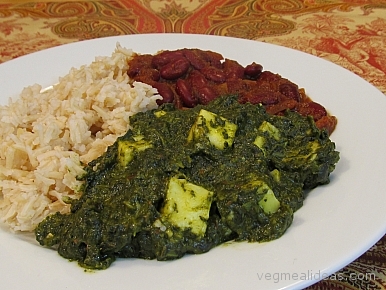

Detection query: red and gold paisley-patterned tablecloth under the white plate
xmin=0 ymin=0 xmax=386 ymax=289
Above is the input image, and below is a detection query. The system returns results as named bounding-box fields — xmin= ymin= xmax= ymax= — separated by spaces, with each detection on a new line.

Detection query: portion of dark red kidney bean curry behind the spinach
xmin=127 ymin=48 xmax=337 ymax=134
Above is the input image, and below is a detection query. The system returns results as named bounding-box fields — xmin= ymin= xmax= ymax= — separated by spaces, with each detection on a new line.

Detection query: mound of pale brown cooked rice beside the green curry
xmin=0 ymin=44 xmax=161 ymax=231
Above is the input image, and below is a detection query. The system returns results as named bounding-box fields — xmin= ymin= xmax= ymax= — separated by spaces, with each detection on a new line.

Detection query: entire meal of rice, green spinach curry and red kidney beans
xmin=0 ymin=45 xmax=339 ymax=269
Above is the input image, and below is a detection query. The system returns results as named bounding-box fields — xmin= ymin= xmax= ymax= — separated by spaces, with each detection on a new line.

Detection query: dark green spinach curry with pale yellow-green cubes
xmin=36 ymin=96 xmax=339 ymax=269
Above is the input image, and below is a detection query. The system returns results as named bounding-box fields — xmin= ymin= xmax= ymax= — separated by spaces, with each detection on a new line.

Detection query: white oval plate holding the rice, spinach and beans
xmin=0 ymin=34 xmax=386 ymax=290
